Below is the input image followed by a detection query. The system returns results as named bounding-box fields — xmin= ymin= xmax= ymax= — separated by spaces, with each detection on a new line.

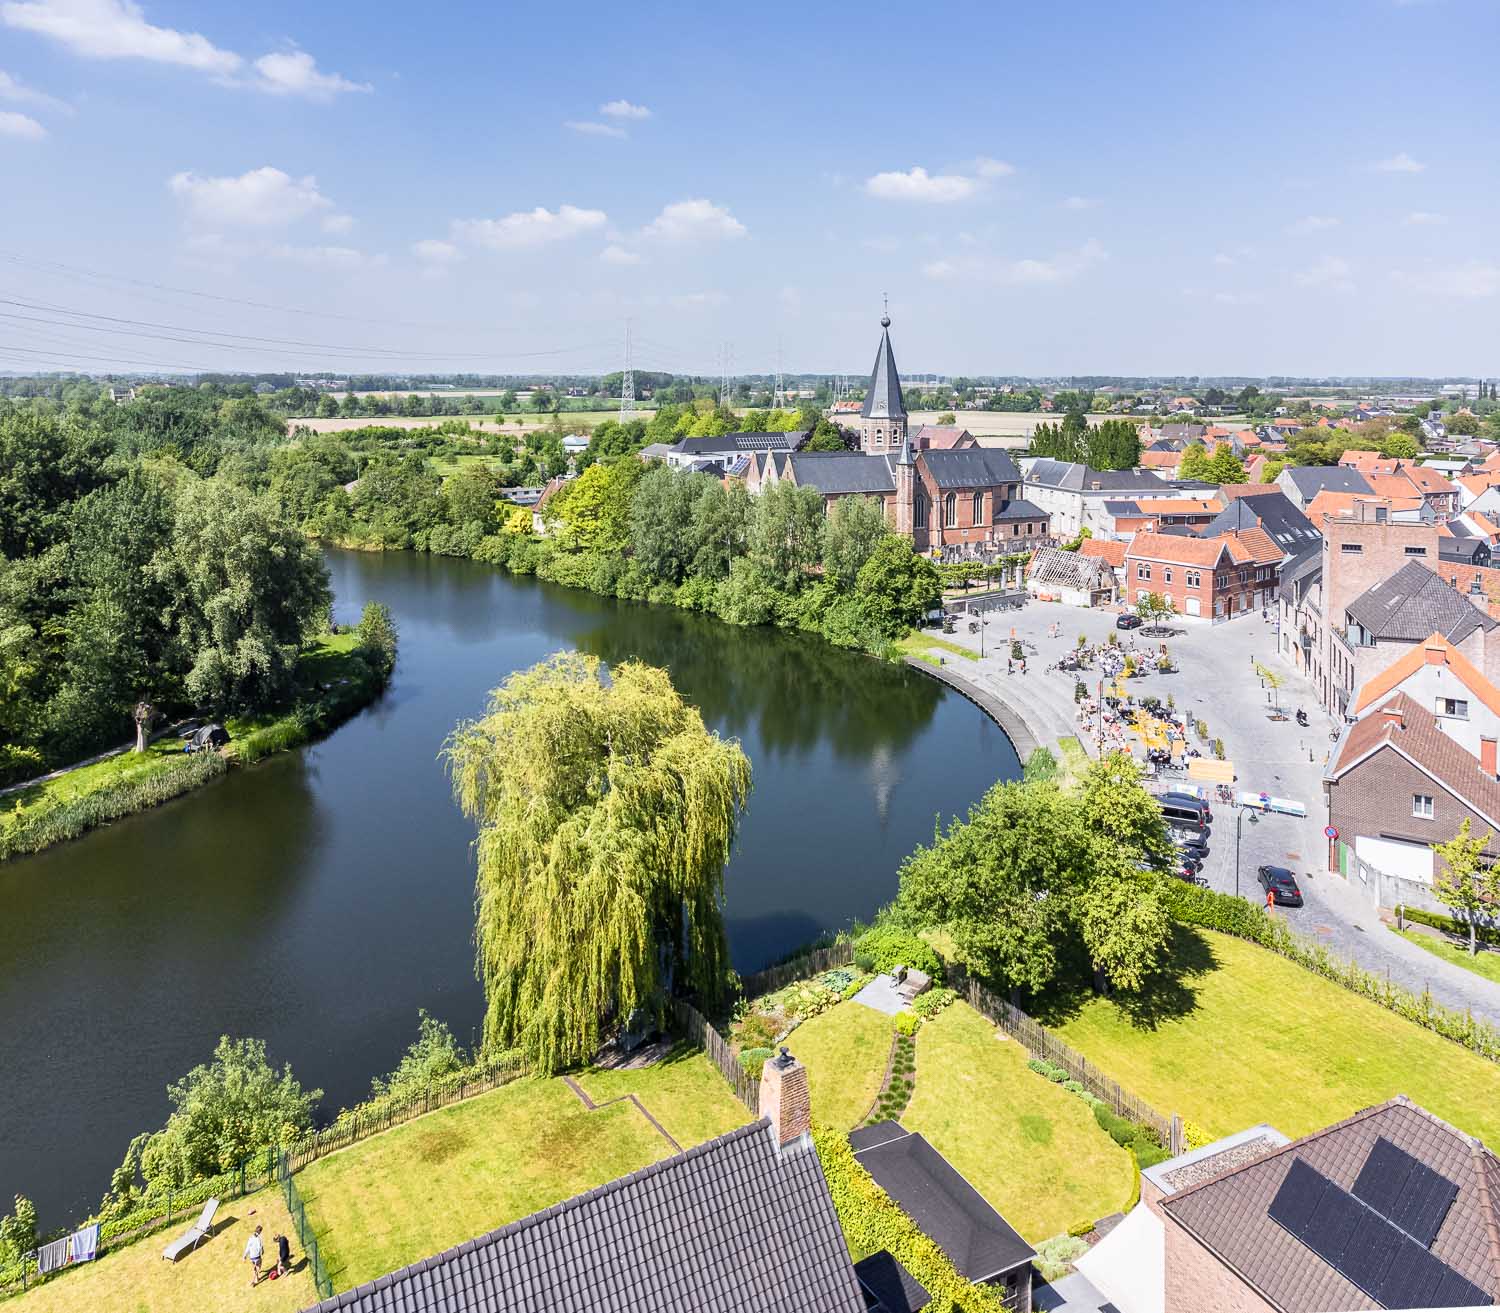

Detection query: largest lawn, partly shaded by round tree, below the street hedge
xmin=1044 ymin=926 xmax=1500 ymax=1145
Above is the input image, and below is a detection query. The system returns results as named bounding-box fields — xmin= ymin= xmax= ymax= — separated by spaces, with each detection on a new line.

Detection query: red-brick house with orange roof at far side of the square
xmin=1124 ymin=528 xmax=1281 ymax=621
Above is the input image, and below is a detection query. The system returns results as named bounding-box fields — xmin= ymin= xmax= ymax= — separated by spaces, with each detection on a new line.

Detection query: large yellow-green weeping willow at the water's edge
xmin=444 ymin=653 xmax=750 ymax=1073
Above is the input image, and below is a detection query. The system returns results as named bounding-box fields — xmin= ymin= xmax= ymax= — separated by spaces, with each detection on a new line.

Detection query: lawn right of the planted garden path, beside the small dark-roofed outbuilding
xmin=902 ymin=1002 xmax=1133 ymax=1244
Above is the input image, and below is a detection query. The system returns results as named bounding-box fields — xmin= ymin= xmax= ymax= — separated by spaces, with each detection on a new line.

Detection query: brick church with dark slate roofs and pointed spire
xmin=746 ymin=314 xmax=1047 ymax=554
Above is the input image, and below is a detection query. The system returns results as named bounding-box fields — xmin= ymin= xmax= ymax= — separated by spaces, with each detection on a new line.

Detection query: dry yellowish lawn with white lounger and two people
xmin=5 ymin=1190 xmax=318 ymax=1313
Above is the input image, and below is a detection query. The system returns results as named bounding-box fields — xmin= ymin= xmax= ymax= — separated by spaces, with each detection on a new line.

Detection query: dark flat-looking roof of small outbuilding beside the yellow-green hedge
xmin=849 ymin=1127 xmax=1037 ymax=1281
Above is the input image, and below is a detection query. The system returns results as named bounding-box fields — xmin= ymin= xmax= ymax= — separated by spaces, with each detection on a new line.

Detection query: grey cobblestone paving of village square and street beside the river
xmin=918 ymin=602 xmax=1500 ymax=1025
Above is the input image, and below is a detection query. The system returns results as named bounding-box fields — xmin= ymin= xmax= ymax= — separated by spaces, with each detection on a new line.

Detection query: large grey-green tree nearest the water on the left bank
xmin=147 ymin=479 xmax=332 ymax=711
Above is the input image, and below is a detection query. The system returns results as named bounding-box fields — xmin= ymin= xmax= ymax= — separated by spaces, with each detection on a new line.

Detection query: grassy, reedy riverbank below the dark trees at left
xmin=0 ymin=630 xmax=386 ymax=861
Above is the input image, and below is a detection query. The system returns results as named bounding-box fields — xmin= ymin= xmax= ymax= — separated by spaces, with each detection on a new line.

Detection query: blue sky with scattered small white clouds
xmin=0 ymin=0 xmax=1500 ymax=375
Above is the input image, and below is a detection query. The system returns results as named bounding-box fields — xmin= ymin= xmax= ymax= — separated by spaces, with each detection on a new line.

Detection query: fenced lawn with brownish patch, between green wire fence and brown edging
xmin=296 ymin=1073 xmax=672 ymax=1290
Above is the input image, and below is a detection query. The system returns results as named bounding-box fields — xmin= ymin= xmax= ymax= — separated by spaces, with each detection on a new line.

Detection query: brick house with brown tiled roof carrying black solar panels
xmin=1142 ymin=1095 xmax=1500 ymax=1313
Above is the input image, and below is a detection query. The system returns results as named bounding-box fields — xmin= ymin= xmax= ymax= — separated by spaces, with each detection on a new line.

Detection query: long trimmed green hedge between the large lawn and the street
xmin=1166 ymin=879 xmax=1500 ymax=1062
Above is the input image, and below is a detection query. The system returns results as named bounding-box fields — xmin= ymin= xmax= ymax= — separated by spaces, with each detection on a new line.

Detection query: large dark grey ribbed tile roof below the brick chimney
xmin=301 ymin=1118 xmax=866 ymax=1313
